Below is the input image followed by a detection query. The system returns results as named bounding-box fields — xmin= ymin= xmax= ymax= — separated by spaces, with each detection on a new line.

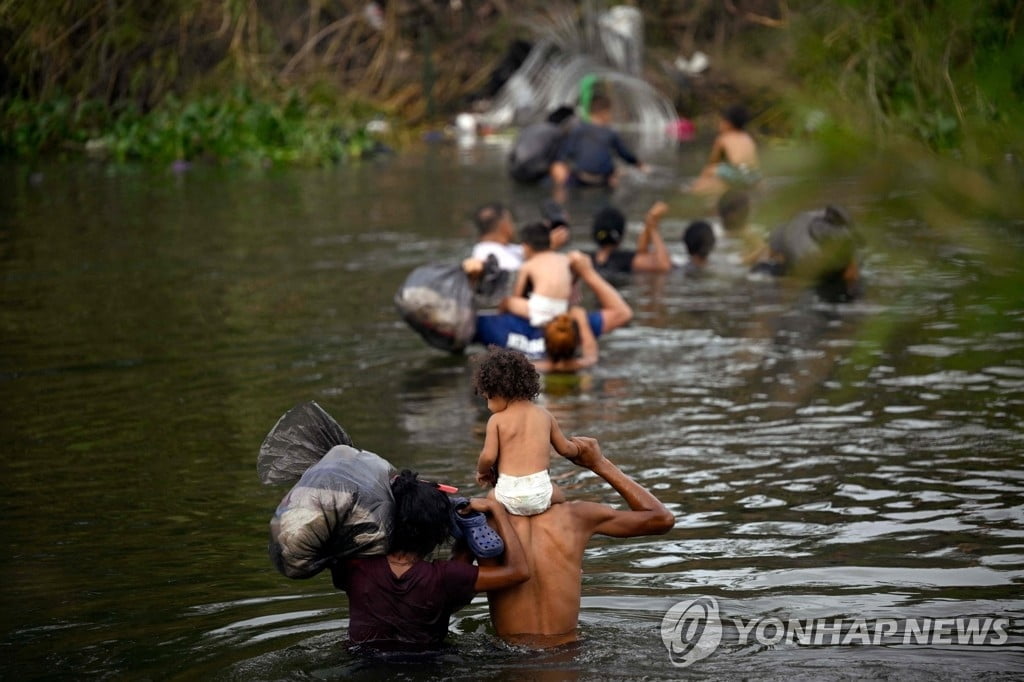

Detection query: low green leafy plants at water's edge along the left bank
xmin=0 ymin=87 xmax=381 ymax=166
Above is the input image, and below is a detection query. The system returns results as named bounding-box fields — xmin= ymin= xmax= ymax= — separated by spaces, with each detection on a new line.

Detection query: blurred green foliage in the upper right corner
xmin=790 ymin=0 xmax=1024 ymax=155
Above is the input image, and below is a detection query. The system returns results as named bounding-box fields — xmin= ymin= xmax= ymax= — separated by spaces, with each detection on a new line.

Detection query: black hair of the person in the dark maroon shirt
xmin=388 ymin=469 xmax=452 ymax=556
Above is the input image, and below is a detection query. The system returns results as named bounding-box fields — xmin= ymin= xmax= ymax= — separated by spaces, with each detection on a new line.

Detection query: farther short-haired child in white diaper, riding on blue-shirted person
xmin=503 ymin=222 xmax=572 ymax=327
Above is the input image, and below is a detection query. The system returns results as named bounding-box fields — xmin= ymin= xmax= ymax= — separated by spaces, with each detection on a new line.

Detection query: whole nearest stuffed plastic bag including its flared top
xmin=257 ymin=402 xmax=395 ymax=579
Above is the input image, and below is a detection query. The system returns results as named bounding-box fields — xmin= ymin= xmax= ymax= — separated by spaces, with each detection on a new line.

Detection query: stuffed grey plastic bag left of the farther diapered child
xmin=394 ymin=263 xmax=476 ymax=352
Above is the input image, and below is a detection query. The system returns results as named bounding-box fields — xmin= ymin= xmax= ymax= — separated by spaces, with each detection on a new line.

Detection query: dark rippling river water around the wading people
xmin=0 ymin=139 xmax=1024 ymax=680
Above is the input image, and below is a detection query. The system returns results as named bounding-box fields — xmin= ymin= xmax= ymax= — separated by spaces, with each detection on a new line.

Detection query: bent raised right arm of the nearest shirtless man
xmin=571 ymin=436 xmax=676 ymax=538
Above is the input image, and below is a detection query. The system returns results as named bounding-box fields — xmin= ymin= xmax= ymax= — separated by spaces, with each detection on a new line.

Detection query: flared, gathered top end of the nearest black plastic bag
xmin=256 ymin=401 xmax=352 ymax=485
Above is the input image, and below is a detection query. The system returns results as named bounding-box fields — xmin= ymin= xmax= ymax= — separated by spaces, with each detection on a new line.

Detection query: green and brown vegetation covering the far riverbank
xmin=0 ymin=0 xmax=1024 ymax=174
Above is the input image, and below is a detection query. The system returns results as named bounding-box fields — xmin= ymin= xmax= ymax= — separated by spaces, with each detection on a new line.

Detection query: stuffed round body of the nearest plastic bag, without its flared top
xmin=269 ymin=445 xmax=395 ymax=579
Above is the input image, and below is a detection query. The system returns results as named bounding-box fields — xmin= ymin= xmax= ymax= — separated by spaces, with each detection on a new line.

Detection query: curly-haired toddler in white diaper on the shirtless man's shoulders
xmin=473 ymin=348 xmax=580 ymax=516
